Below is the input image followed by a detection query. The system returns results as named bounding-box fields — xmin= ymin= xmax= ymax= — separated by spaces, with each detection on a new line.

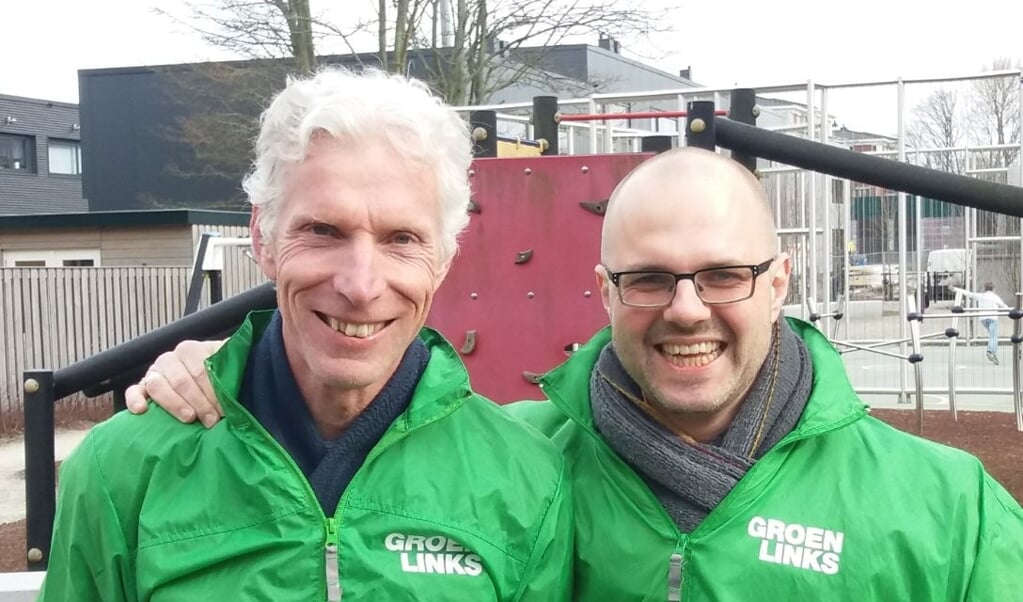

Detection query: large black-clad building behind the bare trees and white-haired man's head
xmin=79 ymin=38 xmax=696 ymax=211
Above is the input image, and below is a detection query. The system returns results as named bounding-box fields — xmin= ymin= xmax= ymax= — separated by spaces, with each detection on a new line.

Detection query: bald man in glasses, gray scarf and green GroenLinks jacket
xmin=131 ymin=148 xmax=1023 ymax=602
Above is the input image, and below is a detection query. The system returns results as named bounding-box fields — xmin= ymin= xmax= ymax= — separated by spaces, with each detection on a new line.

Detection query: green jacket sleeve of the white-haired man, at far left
xmin=38 ymin=433 xmax=136 ymax=602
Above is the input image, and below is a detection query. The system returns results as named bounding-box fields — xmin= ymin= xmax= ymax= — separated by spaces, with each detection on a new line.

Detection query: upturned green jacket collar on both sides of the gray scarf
xmin=540 ymin=317 xmax=866 ymax=441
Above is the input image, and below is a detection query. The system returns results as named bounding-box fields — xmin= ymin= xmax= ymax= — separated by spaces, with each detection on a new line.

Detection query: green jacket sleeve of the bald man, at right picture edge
xmin=966 ymin=475 xmax=1023 ymax=602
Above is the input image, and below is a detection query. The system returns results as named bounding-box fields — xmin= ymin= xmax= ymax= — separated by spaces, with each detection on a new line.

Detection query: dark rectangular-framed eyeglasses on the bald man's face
xmin=604 ymin=257 xmax=774 ymax=308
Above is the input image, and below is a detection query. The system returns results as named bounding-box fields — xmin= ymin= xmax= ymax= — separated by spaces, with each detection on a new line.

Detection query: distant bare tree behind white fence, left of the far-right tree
xmin=906 ymin=89 xmax=966 ymax=173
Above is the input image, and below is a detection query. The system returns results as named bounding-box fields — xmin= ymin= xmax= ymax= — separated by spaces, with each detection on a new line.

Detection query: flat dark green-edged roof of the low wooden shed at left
xmin=0 ymin=209 xmax=250 ymax=230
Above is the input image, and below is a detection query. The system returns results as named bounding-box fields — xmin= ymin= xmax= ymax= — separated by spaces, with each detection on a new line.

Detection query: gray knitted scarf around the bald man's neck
xmin=589 ymin=318 xmax=813 ymax=532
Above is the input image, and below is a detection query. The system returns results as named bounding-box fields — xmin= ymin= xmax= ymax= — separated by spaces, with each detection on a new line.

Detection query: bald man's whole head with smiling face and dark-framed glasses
xmin=593 ymin=148 xmax=792 ymax=441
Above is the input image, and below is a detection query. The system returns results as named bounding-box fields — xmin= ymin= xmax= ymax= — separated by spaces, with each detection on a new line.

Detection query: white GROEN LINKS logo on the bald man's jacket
xmin=746 ymin=516 xmax=845 ymax=574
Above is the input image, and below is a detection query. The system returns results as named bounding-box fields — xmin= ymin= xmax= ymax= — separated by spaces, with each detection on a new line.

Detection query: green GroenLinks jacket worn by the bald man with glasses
xmin=512 ymin=320 xmax=1023 ymax=602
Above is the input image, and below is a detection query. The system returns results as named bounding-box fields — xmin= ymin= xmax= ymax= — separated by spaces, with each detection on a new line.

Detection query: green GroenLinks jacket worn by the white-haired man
xmin=40 ymin=313 xmax=572 ymax=602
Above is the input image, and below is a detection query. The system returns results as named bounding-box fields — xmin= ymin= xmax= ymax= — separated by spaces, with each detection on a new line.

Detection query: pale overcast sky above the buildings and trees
xmin=0 ymin=0 xmax=1023 ymax=131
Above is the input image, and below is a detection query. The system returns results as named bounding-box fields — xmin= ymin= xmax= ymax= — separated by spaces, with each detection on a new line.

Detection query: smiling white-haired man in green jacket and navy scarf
xmin=40 ymin=71 xmax=572 ymax=601
